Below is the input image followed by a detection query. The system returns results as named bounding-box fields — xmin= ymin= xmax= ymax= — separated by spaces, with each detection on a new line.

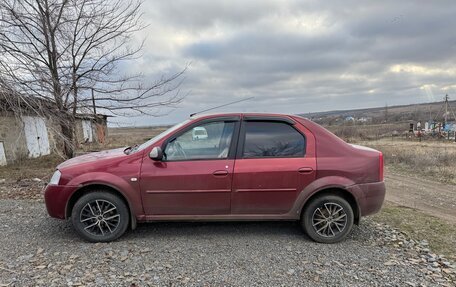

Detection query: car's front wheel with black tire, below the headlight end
xmin=71 ymin=191 xmax=130 ymax=242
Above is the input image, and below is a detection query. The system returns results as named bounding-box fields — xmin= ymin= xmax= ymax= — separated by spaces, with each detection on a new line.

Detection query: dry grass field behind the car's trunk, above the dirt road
xmin=356 ymin=138 xmax=456 ymax=184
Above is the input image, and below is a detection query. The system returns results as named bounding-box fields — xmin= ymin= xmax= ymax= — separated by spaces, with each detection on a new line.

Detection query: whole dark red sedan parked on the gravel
xmin=45 ymin=113 xmax=385 ymax=243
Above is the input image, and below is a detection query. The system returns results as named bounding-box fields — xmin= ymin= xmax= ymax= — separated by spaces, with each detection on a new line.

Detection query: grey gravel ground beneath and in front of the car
xmin=0 ymin=198 xmax=456 ymax=286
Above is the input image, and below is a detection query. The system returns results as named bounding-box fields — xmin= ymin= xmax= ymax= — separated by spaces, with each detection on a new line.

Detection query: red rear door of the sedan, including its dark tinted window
xmin=231 ymin=117 xmax=316 ymax=214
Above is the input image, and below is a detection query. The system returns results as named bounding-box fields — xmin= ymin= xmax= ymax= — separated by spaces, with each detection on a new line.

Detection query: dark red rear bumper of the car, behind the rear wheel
xmin=348 ymin=181 xmax=386 ymax=216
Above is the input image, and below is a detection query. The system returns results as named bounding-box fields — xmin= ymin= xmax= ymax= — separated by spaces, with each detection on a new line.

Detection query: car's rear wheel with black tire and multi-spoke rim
xmin=301 ymin=195 xmax=354 ymax=244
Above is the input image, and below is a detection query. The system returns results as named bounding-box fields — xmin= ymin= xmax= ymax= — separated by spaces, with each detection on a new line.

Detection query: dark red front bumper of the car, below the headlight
xmin=44 ymin=184 xmax=77 ymax=219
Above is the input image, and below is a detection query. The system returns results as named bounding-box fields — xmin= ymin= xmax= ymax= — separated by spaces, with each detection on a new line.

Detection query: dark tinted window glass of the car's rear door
xmin=242 ymin=121 xmax=306 ymax=158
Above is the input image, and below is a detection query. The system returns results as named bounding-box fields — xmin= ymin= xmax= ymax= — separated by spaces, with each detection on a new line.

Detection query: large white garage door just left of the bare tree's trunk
xmin=22 ymin=117 xmax=51 ymax=157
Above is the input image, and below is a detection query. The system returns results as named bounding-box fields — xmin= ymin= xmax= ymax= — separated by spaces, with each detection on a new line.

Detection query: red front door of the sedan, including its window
xmin=140 ymin=117 xmax=239 ymax=215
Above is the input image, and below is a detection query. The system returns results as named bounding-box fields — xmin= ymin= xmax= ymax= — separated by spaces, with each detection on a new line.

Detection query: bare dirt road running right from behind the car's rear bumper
xmin=385 ymin=172 xmax=456 ymax=223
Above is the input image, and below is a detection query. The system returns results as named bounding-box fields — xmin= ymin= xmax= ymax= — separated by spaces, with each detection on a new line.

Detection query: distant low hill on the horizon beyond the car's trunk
xmin=301 ymin=100 xmax=456 ymax=125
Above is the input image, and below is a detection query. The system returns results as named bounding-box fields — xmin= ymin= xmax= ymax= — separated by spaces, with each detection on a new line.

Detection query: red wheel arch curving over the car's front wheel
xmin=65 ymin=186 xmax=137 ymax=230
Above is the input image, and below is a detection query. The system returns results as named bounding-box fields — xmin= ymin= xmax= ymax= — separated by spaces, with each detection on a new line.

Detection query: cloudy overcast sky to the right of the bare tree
xmin=113 ymin=0 xmax=456 ymax=125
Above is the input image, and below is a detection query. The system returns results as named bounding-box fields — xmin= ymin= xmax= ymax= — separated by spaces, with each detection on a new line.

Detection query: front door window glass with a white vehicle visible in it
xmin=165 ymin=121 xmax=235 ymax=161
